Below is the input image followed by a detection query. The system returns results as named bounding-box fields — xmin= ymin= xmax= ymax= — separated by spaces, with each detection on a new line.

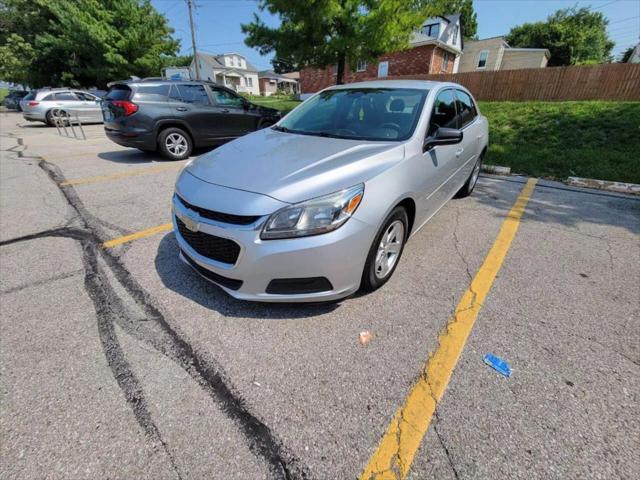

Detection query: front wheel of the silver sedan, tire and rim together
xmin=360 ymin=207 xmax=409 ymax=292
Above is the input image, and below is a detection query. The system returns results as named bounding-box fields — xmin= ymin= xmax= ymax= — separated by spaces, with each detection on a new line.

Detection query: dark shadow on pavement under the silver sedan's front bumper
xmin=155 ymin=232 xmax=340 ymax=319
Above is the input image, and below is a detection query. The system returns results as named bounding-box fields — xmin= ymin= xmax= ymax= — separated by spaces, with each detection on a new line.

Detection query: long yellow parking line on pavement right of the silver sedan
xmin=359 ymin=179 xmax=537 ymax=480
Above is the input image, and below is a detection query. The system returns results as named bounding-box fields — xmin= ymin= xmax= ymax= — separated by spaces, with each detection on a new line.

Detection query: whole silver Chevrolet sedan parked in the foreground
xmin=173 ymin=81 xmax=488 ymax=302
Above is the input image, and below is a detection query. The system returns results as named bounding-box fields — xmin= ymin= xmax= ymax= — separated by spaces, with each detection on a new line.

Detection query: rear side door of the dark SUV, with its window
xmin=169 ymin=83 xmax=220 ymax=146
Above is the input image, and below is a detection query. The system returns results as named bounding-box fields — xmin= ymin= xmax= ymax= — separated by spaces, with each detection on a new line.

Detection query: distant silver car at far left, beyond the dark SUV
xmin=20 ymin=88 xmax=102 ymax=126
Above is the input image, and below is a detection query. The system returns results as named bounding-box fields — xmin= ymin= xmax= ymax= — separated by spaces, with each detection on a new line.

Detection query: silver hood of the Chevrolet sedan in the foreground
xmin=187 ymin=128 xmax=404 ymax=203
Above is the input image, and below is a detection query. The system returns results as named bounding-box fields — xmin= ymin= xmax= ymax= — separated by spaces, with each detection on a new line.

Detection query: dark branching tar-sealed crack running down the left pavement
xmin=10 ymin=138 xmax=310 ymax=480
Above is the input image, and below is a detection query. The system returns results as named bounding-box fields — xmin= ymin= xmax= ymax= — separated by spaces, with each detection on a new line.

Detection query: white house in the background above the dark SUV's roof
xmin=189 ymin=52 xmax=260 ymax=95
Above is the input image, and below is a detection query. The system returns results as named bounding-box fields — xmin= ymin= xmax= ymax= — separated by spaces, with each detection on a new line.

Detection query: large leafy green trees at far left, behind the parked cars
xmin=0 ymin=0 xmax=180 ymax=87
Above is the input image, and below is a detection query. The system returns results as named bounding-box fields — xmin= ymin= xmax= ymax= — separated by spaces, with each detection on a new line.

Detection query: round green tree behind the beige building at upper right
xmin=506 ymin=7 xmax=615 ymax=65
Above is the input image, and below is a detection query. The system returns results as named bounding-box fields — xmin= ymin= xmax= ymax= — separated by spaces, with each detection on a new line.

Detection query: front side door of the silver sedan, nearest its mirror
xmin=416 ymin=88 xmax=461 ymax=222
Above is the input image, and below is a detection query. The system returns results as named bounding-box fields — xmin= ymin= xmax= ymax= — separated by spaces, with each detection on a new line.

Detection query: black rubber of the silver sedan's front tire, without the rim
xmin=360 ymin=207 xmax=409 ymax=292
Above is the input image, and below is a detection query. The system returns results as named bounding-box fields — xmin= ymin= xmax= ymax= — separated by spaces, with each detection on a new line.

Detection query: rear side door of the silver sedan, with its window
xmin=455 ymin=89 xmax=484 ymax=188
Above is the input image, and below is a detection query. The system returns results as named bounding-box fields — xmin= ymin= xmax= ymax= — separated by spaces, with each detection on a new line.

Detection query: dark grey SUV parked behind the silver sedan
xmin=102 ymin=80 xmax=280 ymax=160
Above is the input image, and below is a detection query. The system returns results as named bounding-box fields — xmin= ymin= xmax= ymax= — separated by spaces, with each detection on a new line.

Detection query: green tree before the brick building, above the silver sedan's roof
xmin=242 ymin=0 xmax=434 ymax=84
